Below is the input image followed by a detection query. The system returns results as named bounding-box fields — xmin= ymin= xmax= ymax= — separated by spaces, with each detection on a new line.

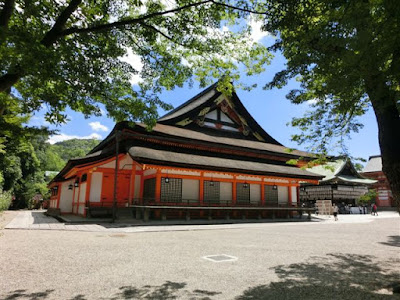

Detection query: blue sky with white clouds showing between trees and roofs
xmin=30 ymin=22 xmax=380 ymax=164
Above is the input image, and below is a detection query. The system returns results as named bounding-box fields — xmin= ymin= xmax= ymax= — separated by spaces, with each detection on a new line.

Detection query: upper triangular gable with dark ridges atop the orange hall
xmin=157 ymin=83 xmax=282 ymax=146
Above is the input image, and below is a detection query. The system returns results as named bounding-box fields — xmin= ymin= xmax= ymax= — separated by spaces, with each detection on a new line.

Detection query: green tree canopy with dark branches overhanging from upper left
xmin=0 ymin=0 xmax=269 ymax=125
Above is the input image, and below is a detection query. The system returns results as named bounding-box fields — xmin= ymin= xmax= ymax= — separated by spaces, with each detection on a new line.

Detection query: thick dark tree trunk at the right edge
xmin=367 ymin=78 xmax=400 ymax=213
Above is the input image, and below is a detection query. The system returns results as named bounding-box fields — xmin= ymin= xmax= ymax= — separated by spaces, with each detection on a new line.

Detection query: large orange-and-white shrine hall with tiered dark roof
xmin=49 ymin=84 xmax=322 ymax=219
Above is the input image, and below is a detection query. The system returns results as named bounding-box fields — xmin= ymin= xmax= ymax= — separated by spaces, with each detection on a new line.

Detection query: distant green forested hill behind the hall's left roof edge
xmin=43 ymin=139 xmax=100 ymax=171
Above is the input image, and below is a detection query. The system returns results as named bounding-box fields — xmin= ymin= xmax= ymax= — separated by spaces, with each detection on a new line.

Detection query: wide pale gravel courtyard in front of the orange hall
xmin=0 ymin=212 xmax=400 ymax=300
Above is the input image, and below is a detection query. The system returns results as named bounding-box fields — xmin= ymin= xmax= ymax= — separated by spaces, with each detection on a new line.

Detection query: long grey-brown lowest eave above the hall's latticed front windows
xmin=129 ymin=147 xmax=322 ymax=180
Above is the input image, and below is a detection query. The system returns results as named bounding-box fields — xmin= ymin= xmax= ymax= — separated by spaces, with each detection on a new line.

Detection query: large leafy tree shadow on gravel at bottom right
xmin=236 ymin=254 xmax=400 ymax=300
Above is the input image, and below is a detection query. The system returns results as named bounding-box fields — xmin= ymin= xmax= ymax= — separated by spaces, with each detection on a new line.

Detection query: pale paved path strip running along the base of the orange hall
xmin=5 ymin=211 xmax=399 ymax=233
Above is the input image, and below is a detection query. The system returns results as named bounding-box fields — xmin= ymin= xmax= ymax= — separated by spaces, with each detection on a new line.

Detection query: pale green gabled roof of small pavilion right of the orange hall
xmin=307 ymin=159 xmax=376 ymax=184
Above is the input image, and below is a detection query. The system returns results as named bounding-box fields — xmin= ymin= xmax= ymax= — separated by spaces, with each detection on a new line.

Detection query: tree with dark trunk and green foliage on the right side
xmin=264 ymin=0 xmax=400 ymax=211
